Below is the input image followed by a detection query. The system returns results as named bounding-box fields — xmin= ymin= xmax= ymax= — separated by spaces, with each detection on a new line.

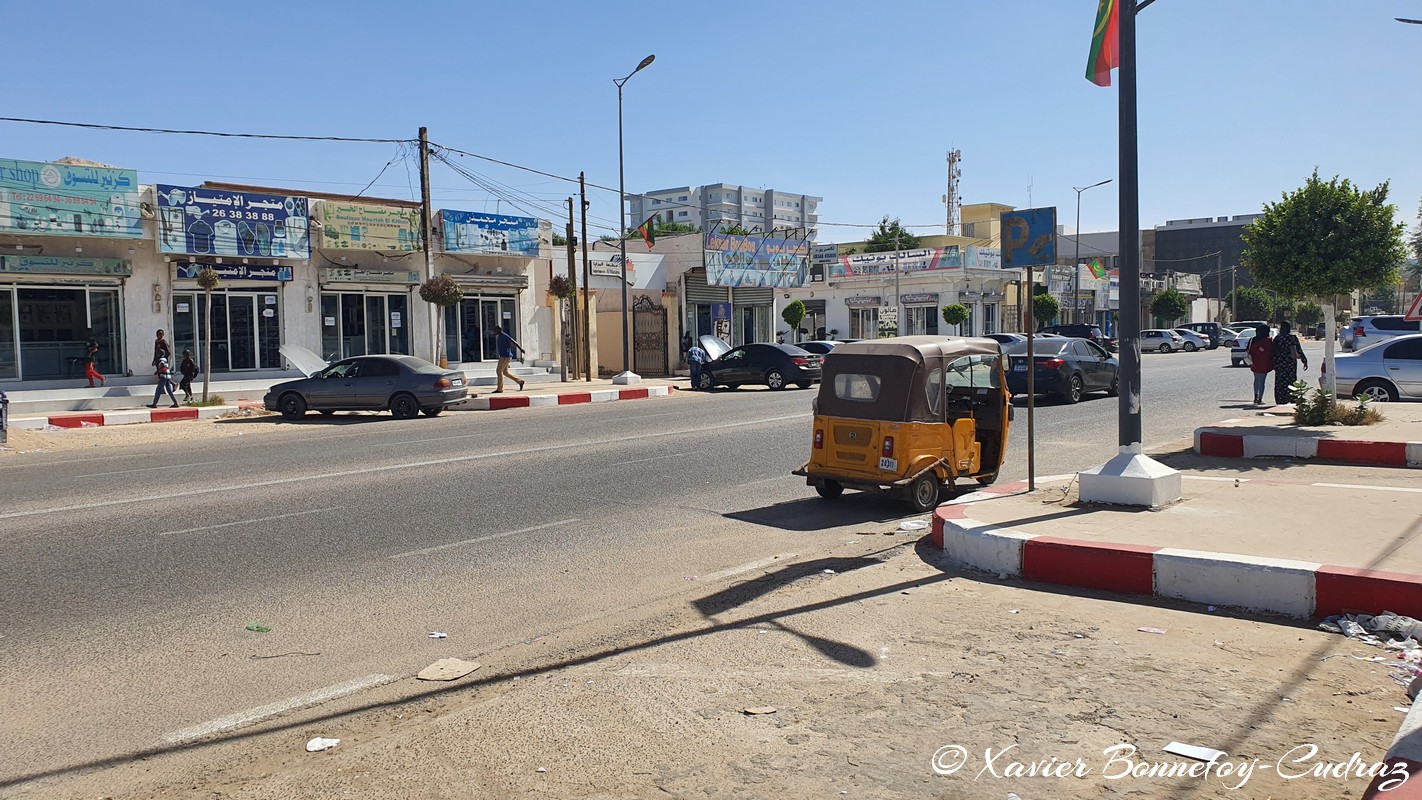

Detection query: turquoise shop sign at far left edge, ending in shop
xmin=0 ymin=159 xmax=144 ymax=239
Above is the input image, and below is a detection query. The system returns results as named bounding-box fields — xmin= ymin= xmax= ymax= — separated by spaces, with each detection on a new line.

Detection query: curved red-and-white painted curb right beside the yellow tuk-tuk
xmin=931 ymin=482 xmax=1422 ymax=618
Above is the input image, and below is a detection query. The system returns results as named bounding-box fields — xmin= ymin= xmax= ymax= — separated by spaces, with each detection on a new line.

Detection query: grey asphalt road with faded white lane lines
xmin=0 ymin=342 xmax=1302 ymax=791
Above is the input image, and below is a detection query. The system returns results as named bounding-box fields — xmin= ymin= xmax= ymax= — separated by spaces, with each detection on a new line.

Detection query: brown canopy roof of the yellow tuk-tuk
xmin=815 ymin=337 xmax=1001 ymax=422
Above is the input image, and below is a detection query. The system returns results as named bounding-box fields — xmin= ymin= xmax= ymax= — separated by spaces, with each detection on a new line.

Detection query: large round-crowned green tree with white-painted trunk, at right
xmin=1240 ymin=169 xmax=1406 ymax=402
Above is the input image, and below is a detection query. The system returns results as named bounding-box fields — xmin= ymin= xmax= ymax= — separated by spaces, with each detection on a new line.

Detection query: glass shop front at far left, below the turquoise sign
xmin=0 ymin=256 xmax=132 ymax=381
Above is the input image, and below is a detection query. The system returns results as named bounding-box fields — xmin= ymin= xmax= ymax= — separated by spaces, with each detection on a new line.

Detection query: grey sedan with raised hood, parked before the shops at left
xmin=262 ymin=355 xmax=469 ymax=419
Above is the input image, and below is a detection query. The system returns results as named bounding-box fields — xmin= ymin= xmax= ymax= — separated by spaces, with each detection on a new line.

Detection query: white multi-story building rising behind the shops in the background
xmin=627 ymin=183 xmax=823 ymax=239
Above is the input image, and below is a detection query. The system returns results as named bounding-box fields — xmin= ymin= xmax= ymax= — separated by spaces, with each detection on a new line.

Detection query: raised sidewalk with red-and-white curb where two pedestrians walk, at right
xmin=1194 ymin=402 xmax=1422 ymax=466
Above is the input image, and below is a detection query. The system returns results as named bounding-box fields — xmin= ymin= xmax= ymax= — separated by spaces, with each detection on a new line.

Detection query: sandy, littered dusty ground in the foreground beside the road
xmin=24 ymin=529 xmax=1406 ymax=800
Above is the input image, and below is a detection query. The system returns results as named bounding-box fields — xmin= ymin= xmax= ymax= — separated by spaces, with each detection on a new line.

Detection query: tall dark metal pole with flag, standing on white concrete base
xmin=1116 ymin=0 xmax=1142 ymax=448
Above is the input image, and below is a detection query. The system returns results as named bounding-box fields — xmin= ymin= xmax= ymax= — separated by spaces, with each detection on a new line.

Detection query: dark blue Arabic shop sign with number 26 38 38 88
xmin=155 ymin=183 xmax=311 ymax=259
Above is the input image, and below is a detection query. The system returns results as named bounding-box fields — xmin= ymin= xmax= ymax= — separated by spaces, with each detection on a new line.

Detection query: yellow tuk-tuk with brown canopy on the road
xmin=793 ymin=337 xmax=1012 ymax=512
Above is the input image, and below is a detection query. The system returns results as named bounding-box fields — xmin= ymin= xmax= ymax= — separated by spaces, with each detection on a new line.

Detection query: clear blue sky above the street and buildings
xmin=0 ymin=0 xmax=1422 ymax=240
